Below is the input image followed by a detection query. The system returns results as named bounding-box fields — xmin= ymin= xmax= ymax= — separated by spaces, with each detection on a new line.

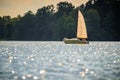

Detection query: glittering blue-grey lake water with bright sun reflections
xmin=0 ymin=41 xmax=120 ymax=80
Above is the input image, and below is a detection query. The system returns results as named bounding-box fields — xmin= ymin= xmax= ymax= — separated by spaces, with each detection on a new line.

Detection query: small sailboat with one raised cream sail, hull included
xmin=63 ymin=11 xmax=89 ymax=44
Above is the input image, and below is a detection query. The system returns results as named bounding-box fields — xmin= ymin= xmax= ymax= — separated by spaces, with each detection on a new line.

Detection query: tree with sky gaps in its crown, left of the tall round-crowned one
xmin=36 ymin=5 xmax=55 ymax=40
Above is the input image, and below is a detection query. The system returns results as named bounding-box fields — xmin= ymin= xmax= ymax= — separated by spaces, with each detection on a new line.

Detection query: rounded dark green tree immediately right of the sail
xmin=85 ymin=9 xmax=102 ymax=40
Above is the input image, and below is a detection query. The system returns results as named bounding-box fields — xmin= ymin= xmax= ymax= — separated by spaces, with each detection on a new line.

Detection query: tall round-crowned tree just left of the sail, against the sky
xmin=55 ymin=2 xmax=75 ymax=40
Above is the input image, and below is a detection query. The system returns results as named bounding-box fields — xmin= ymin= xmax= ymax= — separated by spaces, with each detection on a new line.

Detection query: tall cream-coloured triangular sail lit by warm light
xmin=77 ymin=11 xmax=87 ymax=39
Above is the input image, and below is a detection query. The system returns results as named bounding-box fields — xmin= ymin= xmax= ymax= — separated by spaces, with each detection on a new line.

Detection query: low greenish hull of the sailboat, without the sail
xmin=63 ymin=38 xmax=89 ymax=44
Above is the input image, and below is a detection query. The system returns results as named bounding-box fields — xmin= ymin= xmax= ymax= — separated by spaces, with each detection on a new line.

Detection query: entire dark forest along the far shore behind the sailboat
xmin=0 ymin=0 xmax=120 ymax=41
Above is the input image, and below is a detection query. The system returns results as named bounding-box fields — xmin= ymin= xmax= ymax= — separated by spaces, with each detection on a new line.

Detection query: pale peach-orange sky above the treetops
xmin=0 ymin=0 xmax=88 ymax=17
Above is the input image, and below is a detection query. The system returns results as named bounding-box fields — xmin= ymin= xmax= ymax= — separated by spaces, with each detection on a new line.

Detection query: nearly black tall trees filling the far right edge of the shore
xmin=88 ymin=0 xmax=120 ymax=40
